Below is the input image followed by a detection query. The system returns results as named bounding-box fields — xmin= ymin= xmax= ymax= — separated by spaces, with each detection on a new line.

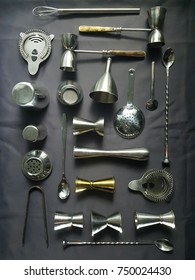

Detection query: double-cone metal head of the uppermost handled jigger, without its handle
xmin=148 ymin=6 xmax=167 ymax=48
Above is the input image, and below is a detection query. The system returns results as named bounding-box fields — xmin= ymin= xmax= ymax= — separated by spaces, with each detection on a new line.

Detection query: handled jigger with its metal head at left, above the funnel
xmin=60 ymin=33 xmax=146 ymax=72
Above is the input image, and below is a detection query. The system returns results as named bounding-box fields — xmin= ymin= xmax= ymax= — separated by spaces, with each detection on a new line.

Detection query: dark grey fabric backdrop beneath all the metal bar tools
xmin=0 ymin=0 xmax=195 ymax=259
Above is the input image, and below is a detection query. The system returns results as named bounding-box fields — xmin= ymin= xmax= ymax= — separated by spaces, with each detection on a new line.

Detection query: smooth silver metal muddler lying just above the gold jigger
xmin=73 ymin=146 xmax=150 ymax=161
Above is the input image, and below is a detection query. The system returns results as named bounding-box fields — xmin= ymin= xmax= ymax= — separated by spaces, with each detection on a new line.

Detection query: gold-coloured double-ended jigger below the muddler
xmin=75 ymin=177 xmax=115 ymax=193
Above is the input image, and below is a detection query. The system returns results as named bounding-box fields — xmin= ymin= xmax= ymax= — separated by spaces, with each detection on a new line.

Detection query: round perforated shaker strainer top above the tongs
xmin=22 ymin=150 xmax=52 ymax=181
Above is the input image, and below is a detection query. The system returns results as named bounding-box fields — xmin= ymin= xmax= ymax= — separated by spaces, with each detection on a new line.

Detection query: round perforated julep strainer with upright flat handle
xmin=114 ymin=69 xmax=145 ymax=139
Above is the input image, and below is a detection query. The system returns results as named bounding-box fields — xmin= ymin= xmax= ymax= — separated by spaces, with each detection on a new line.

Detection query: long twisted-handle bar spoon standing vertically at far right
xmin=162 ymin=48 xmax=175 ymax=167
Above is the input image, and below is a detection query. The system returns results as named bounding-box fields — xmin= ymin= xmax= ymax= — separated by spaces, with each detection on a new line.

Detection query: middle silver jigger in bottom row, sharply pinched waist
xmin=91 ymin=211 xmax=123 ymax=236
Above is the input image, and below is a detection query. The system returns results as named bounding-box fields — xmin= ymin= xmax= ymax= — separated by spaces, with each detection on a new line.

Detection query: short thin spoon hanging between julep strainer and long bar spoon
xmin=146 ymin=61 xmax=158 ymax=111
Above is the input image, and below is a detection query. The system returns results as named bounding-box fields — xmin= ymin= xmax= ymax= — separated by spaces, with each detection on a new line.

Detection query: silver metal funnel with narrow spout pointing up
xmin=89 ymin=57 xmax=118 ymax=103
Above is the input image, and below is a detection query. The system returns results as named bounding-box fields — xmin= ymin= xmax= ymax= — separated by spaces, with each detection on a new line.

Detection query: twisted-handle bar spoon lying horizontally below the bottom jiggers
xmin=63 ymin=239 xmax=173 ymax=252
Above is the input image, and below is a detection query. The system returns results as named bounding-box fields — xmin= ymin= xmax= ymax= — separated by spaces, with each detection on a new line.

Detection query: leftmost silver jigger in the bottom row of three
xmin=54 ymin=212 xmax=83 ymax=231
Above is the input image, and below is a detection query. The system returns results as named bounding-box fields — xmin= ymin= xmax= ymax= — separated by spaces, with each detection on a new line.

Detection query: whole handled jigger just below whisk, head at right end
xmin=79 ymin=6 xmax=166 ymax=48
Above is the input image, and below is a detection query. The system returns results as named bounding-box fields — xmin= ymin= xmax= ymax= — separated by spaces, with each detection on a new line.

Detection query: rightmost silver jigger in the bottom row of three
xmin=135 ymin=210 xmax=175 ymax=229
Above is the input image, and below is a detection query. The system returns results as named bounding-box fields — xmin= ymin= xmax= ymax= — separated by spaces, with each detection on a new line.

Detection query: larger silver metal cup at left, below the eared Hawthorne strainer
xmin=12 ymin=82 xmax=49 ymax=110
